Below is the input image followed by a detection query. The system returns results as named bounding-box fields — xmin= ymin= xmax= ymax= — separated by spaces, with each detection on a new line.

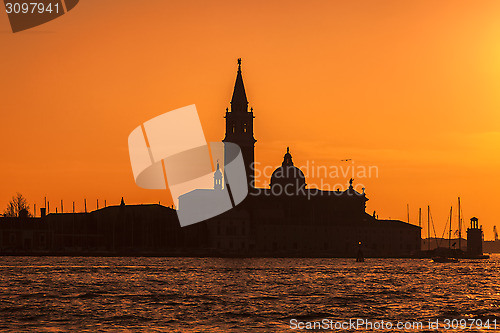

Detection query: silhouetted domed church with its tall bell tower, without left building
xmin=179 ymin=59 xmax=420 ymax=256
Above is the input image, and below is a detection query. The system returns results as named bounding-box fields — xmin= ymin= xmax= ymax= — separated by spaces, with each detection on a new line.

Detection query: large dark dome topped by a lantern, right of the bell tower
xmin=269 ymin=147 xmax=306 ymax=195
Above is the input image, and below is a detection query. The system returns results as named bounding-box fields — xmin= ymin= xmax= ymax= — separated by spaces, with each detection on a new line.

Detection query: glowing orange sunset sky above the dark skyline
xmin=0 ymin=0 xmax=500 ymax=239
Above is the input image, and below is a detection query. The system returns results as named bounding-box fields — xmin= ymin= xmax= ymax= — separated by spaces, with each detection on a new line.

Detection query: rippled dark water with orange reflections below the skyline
xmin=0 ymin=256 xmax=500 ymax=332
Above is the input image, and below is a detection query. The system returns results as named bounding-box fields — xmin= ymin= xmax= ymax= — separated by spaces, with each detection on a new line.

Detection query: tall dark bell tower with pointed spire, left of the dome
xmin=222 ymin=58 xmax=257 ymax=188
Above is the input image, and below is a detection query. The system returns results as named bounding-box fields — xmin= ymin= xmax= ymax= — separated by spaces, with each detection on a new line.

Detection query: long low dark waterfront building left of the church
xmin=0 ymin=204 xmax=207 ymax=255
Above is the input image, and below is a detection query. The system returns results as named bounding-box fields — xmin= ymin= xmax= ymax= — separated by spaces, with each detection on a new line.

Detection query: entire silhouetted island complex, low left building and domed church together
xmin=0 ymin=59 xmax=421 ymax=257
